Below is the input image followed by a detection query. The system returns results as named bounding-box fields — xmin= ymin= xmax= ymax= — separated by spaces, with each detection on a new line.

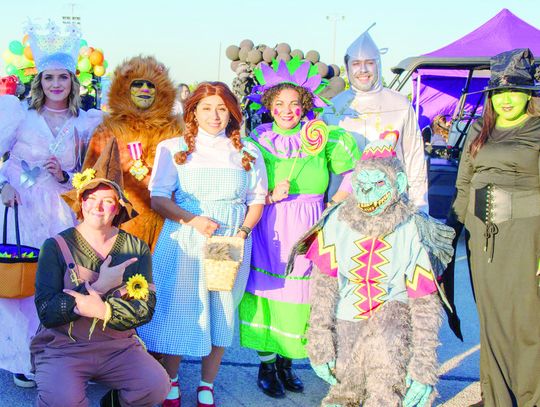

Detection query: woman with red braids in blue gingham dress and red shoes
xmin=138 ymin=84 xmax=267 ymax=406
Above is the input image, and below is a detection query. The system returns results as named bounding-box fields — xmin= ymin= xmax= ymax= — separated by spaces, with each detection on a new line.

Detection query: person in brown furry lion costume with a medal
xmin=83 ymin=56 xmax=181 ymax=251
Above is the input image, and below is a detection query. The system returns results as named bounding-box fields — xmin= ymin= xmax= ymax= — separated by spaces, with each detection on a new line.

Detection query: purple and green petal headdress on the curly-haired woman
xmin=247 ymin=57 xmax=329 ymax=119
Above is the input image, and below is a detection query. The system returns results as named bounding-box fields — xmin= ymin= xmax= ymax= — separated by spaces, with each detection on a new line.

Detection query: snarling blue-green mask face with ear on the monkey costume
xmin=353 ymin=170 xmax=407 ymax=216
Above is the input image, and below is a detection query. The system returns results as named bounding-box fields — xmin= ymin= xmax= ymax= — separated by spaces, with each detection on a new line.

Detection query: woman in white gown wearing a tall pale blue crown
xmin=0 ymin=20 xmax=101 ymax=387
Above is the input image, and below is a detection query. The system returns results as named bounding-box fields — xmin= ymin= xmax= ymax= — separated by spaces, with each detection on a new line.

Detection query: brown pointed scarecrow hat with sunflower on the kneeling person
xmin=62 ymin=137 xmax=138 ymax=226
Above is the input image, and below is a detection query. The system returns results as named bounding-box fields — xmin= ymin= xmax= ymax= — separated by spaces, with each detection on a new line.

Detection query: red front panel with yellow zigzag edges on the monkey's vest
xmin=349 ymin=237 xmax=392 ymax=319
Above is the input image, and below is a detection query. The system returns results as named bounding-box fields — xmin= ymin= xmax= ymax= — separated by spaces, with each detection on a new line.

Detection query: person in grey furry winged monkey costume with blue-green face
xmin=293 ymin=141 xmax=452 ymax=407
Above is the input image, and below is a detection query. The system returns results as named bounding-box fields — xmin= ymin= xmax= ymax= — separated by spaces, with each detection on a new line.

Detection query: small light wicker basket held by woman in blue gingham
xmin=203 ymin=236 xmax=244 ymax=291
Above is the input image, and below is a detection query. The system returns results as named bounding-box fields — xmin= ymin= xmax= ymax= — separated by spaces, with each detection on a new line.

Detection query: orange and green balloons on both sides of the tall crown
xmin=2 ymin=34 xmax=107 ymax=87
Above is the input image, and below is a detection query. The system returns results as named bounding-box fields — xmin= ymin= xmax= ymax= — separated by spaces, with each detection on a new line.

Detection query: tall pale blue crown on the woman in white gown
xmin=25 ymin=20 xmax=81 ymax=73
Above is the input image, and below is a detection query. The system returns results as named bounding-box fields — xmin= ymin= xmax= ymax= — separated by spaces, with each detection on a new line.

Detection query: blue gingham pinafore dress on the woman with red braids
xmin=138 ymin=165 xmax=251 ymax=356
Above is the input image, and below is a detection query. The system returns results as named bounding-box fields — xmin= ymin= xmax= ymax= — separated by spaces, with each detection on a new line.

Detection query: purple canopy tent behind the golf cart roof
xmin=389 ymin=9 xmax=540 ymax=128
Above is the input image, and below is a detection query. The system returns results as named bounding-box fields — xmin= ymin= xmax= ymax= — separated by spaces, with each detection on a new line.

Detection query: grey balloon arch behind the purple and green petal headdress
xmin=225 ymin=40 xmax=345 ymax=98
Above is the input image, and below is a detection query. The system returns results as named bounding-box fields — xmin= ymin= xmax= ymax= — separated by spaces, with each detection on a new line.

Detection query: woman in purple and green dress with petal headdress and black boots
xmin=239 ymin=59 xmax=358 ymax=398
